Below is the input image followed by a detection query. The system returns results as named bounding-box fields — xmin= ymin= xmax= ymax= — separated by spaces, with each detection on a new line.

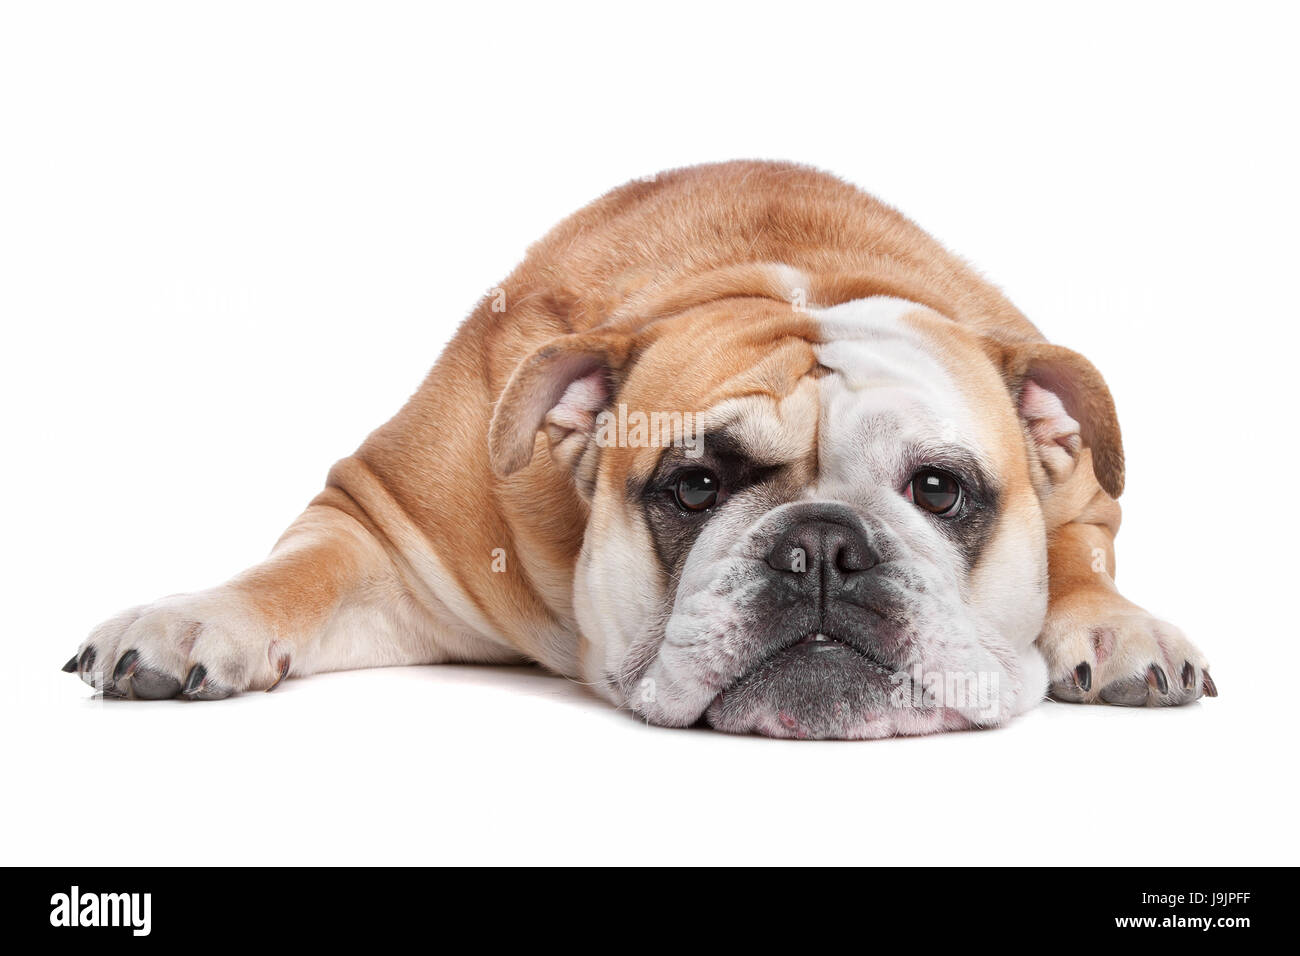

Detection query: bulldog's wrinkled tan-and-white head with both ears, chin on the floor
xmin=490 ymin=298 xmax=1122 ymax=737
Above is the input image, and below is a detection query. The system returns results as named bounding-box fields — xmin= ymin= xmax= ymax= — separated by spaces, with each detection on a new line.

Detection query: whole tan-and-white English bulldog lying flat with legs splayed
xmin=65 ymin=163 xmax=1217 ymax=737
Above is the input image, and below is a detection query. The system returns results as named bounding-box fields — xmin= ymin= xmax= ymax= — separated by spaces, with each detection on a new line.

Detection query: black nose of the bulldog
xmin=767 ymin=515 xmax=880 ymax=602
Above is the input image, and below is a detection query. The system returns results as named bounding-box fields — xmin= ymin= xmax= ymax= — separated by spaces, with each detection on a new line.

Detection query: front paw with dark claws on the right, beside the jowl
xmin=1037 ymin=592 xmax=1218 ymax=708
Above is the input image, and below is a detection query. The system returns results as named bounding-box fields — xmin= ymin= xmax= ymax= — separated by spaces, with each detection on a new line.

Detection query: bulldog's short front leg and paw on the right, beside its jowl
xmin=1037 ymin=462 xmax=1218 ymax=706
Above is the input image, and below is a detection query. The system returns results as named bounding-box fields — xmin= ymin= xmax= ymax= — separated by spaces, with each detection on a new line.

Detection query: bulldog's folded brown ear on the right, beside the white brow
xmin=989 ymin=342 xmax=1125 ymax=498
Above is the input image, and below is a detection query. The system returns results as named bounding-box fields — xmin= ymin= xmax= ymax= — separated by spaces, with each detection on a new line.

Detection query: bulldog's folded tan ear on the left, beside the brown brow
xmin=488 ymin=333 xmax=632 ymax=486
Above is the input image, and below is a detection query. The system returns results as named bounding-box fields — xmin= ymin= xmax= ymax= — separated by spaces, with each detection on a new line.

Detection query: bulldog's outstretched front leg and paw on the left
xmin=66 ymin=460 xmax=511 ymax=700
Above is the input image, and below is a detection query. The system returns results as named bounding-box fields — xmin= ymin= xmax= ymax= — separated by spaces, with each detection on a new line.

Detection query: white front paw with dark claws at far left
xmin=64 ymin=588 xmax=290 ymax=700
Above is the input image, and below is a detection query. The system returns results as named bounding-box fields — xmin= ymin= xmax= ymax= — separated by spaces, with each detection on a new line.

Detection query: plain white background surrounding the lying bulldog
xmin=0 ymin=0 xmax=1300 ymax=864
